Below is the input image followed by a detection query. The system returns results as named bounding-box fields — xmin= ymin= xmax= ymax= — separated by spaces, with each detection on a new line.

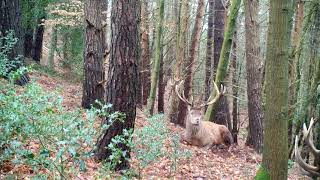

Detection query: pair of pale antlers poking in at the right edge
xmin=294 ymin=118 xmax=320 ymax=177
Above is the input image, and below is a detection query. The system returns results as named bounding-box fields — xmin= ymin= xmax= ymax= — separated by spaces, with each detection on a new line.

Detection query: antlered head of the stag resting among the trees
xmin=175 ymin=81 xmax=225 ymax=125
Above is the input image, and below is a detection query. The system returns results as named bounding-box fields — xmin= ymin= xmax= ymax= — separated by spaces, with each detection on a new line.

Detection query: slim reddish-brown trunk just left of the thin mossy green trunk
xmin=140 ymin=0 xmax=151 ymax=105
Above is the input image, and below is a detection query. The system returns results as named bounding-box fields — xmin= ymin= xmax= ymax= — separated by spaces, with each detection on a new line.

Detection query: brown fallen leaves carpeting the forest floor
xmin=6 ymin=72 xmax=305 ymax=179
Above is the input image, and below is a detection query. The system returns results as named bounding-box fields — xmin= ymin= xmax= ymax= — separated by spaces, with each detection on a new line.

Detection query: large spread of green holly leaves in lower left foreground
xmin=0 ymin=83 xmax=119 ymax=178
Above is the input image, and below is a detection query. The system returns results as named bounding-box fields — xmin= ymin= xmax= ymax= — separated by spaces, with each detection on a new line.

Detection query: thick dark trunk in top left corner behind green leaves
xmin=0 ymin=0 xmax=29 ymax=85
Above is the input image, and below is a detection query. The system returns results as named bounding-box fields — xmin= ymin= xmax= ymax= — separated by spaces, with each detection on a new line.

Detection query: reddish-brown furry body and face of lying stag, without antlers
xmin=183 ymin=109 xmax=233 ymax=149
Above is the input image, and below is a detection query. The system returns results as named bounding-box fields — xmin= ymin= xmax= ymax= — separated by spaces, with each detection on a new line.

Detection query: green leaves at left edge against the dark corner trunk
xmin=0 ymin=31 xmax=21 ymax=77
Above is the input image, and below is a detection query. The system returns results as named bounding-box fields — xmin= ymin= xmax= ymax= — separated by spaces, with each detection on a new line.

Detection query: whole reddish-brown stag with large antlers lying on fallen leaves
xmin=175 ymin=81 xmax=233 ymax=149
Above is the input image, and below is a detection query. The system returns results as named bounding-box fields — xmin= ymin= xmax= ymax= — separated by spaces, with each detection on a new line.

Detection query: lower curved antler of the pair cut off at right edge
xmin=294 ymin=136 xmax=320 ymax=177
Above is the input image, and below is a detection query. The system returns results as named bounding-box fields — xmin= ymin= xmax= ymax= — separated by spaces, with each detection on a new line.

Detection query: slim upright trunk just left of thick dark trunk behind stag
xmin=204 ymin=0 xmax=215 ymax=101
